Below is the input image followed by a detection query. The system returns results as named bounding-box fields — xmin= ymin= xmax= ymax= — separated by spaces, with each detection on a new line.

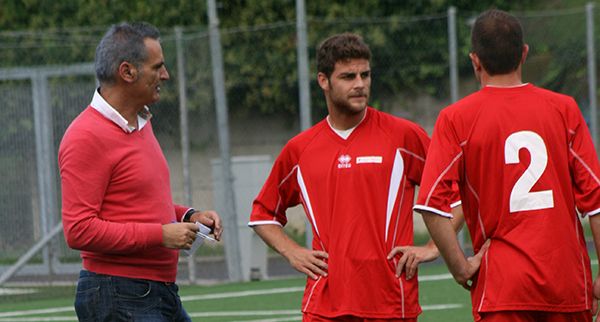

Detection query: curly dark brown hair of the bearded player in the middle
xmin=317 ymin=32 xmax=371 ymax=78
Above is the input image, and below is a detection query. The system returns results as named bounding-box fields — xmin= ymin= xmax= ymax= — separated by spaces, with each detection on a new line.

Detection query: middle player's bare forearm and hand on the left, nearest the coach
xmin=252 ymin=224 xmax=328 ymax=279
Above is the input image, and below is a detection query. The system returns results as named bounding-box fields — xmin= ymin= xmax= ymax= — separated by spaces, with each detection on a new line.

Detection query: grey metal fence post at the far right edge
xmin=585 ymin=2 xmax=598 ymax=148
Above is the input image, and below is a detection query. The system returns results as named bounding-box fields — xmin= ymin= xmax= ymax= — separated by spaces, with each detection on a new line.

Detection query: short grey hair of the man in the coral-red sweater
xmin=94 ymin=22 xmax=160 ymax=84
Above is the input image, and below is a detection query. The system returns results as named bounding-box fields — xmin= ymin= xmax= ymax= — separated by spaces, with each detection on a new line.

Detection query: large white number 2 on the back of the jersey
xmin=504 ymin=131 xmax=554 ymax=212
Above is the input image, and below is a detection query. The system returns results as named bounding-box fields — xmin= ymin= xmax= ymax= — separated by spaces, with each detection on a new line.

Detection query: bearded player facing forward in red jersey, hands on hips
xmin=249 ymin=33 xmax=462 ymax=321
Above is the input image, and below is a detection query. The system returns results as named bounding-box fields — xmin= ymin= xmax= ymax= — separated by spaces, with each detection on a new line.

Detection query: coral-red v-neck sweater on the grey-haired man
xmin=58 ymin=107 xmax=188 ymax=282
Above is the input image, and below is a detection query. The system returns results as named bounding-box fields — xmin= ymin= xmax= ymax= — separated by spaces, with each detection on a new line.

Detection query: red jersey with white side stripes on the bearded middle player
xmin=249 ymin=108 xmax=429 ymax=318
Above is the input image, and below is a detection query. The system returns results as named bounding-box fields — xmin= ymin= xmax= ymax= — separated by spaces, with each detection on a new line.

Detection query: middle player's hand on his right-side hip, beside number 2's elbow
xmin=387 ymin=241 xmax=440 ymax=280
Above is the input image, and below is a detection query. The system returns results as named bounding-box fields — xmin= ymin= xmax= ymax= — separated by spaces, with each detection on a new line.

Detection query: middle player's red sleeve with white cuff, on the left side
xmin=248 ymin=145 xmax=301 ymax=227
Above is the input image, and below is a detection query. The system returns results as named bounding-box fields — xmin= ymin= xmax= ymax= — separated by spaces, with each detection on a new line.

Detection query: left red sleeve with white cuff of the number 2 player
xmin=414 ymin=111 xmax=463 ymax=218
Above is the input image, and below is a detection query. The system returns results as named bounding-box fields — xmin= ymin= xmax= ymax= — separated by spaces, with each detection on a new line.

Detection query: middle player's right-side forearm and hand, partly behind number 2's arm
xmin=388 ymin=205 xmax=465 ymax=279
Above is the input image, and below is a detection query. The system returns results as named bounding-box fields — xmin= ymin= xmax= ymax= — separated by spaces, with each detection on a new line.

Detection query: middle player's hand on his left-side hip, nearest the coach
xmin=281 ymin=246 xmax=329 ymax=280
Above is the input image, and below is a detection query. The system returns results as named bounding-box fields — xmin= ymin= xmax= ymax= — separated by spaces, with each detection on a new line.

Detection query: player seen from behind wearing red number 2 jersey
xmin=414 ymin=10 xmax=600 ymax=322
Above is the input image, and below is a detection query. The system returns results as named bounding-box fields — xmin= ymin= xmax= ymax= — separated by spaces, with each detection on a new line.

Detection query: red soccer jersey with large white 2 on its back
xmin=415 ymin=84 xmax=600 ymax=317
